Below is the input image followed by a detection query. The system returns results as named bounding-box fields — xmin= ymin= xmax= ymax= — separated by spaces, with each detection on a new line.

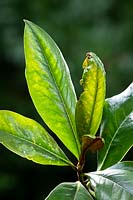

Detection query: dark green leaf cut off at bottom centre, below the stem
xmin=45 ymin=181 xmax=93 ymax=200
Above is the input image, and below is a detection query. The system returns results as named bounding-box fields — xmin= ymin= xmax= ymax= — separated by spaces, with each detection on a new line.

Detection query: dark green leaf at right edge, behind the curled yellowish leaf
xmin=98 ymin=83 xmax=133 ymax=169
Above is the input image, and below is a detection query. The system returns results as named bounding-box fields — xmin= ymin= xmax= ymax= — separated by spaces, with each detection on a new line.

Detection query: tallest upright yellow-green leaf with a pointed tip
xmin=24 ymin=21 xmax=80 ymax=158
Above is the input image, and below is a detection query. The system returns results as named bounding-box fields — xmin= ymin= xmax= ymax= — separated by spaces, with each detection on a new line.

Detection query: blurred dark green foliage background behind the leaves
xmin=0 ymin=0 xmax=133 ymax=200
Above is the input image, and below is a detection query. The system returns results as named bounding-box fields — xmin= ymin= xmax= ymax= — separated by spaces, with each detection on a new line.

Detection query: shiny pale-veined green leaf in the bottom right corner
xmin=88 ymin=162 xmax=133 ymax=200
